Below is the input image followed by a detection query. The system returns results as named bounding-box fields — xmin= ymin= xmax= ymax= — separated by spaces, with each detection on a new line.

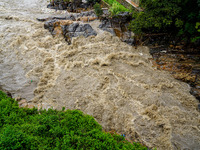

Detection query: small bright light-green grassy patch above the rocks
xmin=103 ymin=0 xmax=130 ymax=16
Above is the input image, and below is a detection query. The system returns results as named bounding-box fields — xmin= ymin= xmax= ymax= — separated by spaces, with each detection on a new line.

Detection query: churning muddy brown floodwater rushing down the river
xmin=0 ymin=0 xmax=200 ymax=150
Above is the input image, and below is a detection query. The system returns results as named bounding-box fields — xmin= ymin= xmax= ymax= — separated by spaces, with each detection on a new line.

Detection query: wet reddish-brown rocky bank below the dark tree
xmin=150 ymin=46 xmax=200 ymax=100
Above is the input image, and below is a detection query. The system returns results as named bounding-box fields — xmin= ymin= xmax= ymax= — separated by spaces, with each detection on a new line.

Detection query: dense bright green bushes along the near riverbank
xmin=0 ymin=91 xmax=147 ymax=150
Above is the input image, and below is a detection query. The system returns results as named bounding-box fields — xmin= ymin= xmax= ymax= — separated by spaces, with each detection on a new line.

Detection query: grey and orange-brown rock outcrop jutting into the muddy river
xmin=37 ymin=11 xmax=97 ymax=44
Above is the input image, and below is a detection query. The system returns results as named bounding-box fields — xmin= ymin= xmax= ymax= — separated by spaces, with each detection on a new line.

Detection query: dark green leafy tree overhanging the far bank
xmin=130 ymin=0 xmax=200 ymax=40
